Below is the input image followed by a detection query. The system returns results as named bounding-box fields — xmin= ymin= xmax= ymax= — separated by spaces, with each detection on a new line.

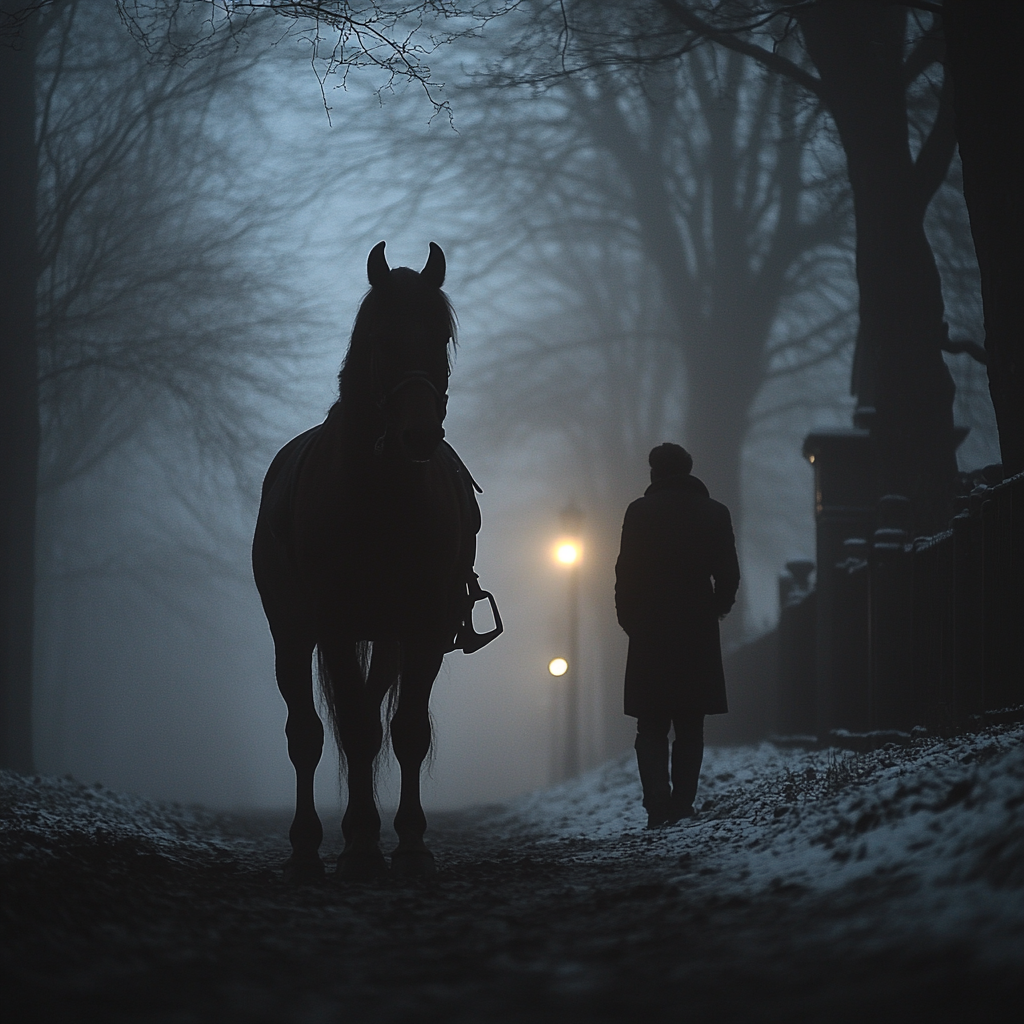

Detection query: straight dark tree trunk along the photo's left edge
xmin=0 ymin=0 xmax=39 ymax=772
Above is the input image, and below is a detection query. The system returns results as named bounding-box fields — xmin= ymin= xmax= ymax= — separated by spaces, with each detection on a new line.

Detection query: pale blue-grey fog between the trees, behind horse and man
xmin=25 ymin=4 xmax=997 ymax=810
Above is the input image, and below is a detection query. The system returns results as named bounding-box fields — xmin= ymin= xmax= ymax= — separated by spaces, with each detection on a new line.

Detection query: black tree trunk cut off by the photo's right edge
xmin=943 ymin=0 xmax=1024 ymax=474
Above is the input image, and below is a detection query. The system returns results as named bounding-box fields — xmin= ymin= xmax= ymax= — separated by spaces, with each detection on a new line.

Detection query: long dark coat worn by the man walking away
xmin=615 ymin=474 xmax=739 ymax=717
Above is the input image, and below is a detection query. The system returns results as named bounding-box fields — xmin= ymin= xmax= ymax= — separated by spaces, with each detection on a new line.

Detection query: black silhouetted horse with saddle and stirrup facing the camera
xmin=252 ymin=242 xmax=501 ymax=882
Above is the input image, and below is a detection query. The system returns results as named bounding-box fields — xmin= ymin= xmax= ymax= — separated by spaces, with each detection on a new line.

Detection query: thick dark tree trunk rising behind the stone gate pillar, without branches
xmin=799 ymin=6 xmax=956 ymax=532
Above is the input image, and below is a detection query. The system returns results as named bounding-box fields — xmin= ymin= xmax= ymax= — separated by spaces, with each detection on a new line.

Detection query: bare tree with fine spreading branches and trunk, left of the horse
xmin=0 ymin=0 xmax=323 ymax=770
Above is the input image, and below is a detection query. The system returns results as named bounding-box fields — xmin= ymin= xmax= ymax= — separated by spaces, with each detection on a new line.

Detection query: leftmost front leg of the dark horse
xmin=275 ymin=641 xmax=324 ymax=882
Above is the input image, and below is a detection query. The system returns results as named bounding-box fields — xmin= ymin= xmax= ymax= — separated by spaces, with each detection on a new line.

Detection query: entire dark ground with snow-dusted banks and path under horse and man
xmin=0 ymin=725 xmax=1024 ymax=1024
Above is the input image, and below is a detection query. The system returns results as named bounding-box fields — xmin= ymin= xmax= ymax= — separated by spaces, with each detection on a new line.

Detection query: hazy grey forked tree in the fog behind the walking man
xmin=552 ymin=52 xmax=847 ymax=532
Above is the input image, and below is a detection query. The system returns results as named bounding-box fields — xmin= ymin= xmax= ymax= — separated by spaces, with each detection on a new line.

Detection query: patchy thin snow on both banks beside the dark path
xmin=0 ymin=723 xmax=1024 ymax=966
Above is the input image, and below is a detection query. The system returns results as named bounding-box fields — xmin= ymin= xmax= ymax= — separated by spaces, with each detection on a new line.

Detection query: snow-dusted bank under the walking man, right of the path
xmin=487 ymin=724 xmax=1024 ymax=964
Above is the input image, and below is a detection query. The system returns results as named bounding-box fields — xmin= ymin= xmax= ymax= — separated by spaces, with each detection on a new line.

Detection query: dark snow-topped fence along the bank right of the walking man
xmin=776 ymin=474 xmax=1024 ymax=735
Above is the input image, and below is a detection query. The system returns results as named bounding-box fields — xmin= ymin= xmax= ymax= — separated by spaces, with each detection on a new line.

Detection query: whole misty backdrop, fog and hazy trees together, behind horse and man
xmin=25 ymin=3 xmax=998 ymax=810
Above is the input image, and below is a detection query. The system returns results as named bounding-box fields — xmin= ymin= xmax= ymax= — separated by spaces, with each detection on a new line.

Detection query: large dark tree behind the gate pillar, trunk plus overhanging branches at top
xmin=516 ymin=0 xmax=978 ymax=531
